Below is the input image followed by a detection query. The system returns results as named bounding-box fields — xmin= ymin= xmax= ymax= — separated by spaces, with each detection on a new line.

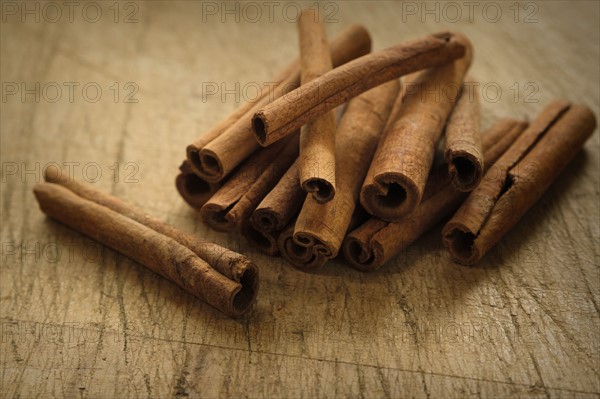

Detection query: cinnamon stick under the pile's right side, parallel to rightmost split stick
xmin=342 ymin=119 xmax=527 ymax=271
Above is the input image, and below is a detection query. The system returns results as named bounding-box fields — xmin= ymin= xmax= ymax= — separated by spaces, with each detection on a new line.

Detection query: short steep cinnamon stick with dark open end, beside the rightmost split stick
xmin=444 ymin=90 xmax=483 ymax=191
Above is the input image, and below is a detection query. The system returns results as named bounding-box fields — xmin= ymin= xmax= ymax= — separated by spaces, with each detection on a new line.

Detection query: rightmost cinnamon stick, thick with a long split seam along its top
xmin=442 ymin=101 xmax=596 ymax=265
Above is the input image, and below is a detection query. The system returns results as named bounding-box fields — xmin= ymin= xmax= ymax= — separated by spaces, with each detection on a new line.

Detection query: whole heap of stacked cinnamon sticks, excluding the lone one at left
xmin=176 ymin=10 xmax=596 ymax=271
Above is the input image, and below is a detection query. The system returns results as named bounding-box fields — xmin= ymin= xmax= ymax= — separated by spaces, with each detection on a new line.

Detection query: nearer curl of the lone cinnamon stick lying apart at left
xmin=34 ymin=183 xmax=258 ymax=317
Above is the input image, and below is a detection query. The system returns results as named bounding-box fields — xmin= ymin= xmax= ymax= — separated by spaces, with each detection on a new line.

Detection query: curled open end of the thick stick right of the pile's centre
xmin=362 ymin=173 xmax=423 ymax=222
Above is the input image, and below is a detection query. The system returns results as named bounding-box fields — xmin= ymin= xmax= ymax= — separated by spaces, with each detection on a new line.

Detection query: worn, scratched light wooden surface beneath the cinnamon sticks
xmin=0 ymin=1 xmax=600 ymax=398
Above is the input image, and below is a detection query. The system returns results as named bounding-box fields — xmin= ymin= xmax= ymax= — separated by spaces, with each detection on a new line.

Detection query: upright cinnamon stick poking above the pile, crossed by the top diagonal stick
xmin=298 ymin=9 xmax=336 ymax=203
